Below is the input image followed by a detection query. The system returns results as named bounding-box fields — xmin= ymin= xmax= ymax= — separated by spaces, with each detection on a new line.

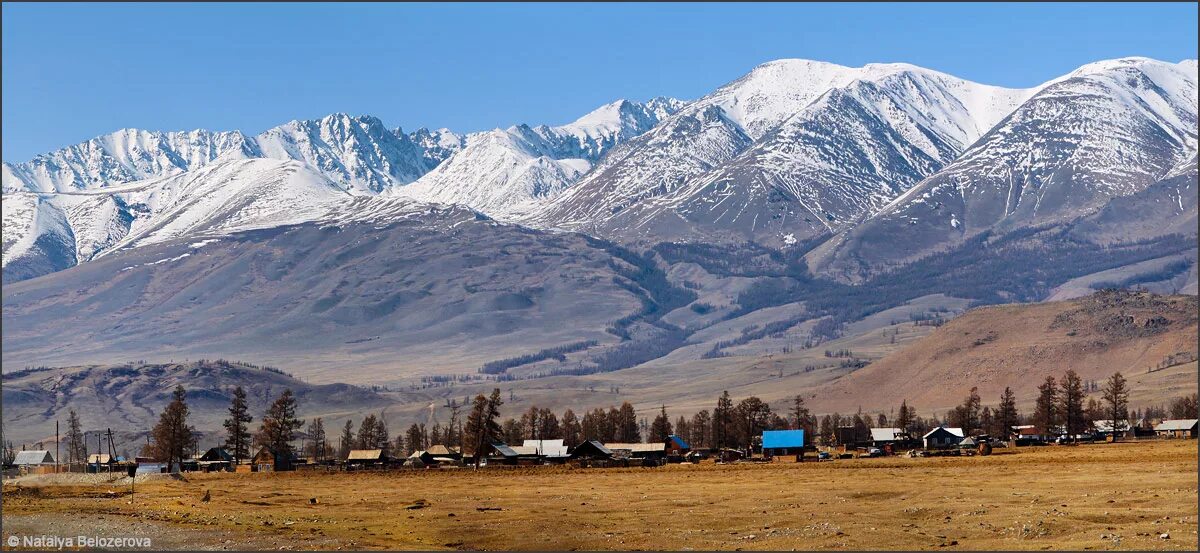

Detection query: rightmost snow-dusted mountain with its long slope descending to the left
xmin=810 ymin=58 xmax=1196 ymax=279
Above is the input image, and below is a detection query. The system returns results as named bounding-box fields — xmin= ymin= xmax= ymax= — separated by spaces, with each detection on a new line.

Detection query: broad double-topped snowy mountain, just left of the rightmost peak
xmin=529 ymin=60 xmax=1034 ymax=247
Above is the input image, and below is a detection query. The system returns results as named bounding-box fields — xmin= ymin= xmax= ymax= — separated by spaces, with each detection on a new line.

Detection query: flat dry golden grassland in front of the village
xmin=4 ymin=440 xmax=1198 ymax=551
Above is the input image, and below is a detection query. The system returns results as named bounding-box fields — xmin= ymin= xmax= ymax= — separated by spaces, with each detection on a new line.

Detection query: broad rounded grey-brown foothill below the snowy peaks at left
xmin=2 ymin=195 xmax=658 ymax=381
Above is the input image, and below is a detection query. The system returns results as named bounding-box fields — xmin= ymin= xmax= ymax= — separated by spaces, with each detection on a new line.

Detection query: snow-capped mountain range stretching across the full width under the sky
xmin=2 ymin=58 xmax=1196 ymax=281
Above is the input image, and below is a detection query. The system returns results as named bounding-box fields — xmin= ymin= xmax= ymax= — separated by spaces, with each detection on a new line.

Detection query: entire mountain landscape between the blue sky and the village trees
xmin=2 ymin=58 xmax=1198 ymax=438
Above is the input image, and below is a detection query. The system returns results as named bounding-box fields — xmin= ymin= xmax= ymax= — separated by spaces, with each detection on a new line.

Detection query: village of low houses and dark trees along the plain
xmin=2 ymin=371 xmax=1198 ymax=477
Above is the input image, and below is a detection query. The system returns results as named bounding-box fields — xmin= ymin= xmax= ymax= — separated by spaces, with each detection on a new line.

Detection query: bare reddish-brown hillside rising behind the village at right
xmin=817 ymin=291 xmax=1198 ymax=411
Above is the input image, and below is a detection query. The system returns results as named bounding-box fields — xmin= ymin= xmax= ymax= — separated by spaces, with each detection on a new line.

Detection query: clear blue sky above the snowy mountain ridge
xmin=2 ymin=2 xmax=1198 ymax=161
